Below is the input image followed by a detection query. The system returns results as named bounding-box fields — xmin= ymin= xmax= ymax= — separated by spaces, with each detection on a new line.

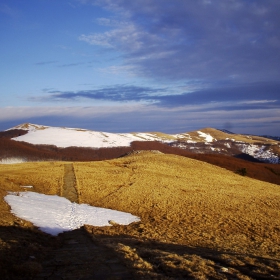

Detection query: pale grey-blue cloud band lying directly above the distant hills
xmin=0 ymin=104 xmax=280 ymax=135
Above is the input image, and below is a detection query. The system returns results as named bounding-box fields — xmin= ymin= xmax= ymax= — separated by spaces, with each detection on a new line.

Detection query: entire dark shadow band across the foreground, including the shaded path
xmin=0 ymin=226 xmax=280 ymax=279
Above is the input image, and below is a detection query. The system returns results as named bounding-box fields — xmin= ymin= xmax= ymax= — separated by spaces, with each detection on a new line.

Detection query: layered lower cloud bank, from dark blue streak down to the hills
xmin=9 ymin=79 xmax=280 ymax=134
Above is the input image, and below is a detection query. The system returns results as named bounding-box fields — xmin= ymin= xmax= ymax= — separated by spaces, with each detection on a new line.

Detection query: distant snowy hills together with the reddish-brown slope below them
xmin=0 ymin=124 xmax=280 ymax=185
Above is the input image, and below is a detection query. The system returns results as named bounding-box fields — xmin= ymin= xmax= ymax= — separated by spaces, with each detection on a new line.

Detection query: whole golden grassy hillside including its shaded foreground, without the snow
xmin=0 ymin=152 xmax=280 ymax=279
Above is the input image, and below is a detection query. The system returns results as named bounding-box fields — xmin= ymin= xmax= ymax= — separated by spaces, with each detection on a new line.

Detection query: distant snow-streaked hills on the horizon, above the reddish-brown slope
xmin=3 ymin=123 xmax=280 ymax=164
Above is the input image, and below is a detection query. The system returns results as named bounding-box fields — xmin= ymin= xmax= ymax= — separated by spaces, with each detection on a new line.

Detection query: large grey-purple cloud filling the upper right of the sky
xmin=80 ymin=0 xmax=280 ymax=81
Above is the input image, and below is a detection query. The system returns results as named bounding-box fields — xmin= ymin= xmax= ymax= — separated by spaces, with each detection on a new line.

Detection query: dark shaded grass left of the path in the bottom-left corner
xmin=0 ymin=226 xmax=60 ymax=279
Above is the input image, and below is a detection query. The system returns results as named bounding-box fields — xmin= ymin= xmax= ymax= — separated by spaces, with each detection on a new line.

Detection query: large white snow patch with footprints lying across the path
xmin=4 ymin=192 xmax=140 ymax=235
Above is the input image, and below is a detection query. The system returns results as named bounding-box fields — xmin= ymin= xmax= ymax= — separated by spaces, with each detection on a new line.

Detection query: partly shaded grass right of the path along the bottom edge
xmin=86 ymin=226 xmax=280 ymax=279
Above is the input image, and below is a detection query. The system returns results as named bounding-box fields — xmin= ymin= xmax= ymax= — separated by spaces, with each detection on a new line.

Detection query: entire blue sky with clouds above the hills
xmin=0 ymin=0 xmax=280 ymax=136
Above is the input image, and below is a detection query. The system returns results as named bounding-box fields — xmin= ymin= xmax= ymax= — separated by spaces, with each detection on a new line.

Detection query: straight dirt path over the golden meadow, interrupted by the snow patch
xmin=35 ymin=164 xmax=134 ymax=280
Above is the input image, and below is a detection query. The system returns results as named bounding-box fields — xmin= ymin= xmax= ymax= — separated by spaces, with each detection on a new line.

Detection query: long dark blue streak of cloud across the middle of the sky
xmin=29 ymin=82 xmax=280 ymax=110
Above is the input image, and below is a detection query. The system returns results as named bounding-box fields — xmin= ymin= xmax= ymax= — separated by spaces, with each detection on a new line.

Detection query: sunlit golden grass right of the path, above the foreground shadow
xmin=74 ymin=153 xmax=280 ymax=257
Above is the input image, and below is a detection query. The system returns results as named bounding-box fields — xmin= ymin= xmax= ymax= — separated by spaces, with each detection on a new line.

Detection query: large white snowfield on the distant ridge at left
xmin=9 ymin=124 xmax=190 ymax=148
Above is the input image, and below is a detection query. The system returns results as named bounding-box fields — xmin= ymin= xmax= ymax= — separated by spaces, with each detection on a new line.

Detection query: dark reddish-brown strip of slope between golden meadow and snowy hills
xmin=0 ymin=137 xmax=280 ymax=185
